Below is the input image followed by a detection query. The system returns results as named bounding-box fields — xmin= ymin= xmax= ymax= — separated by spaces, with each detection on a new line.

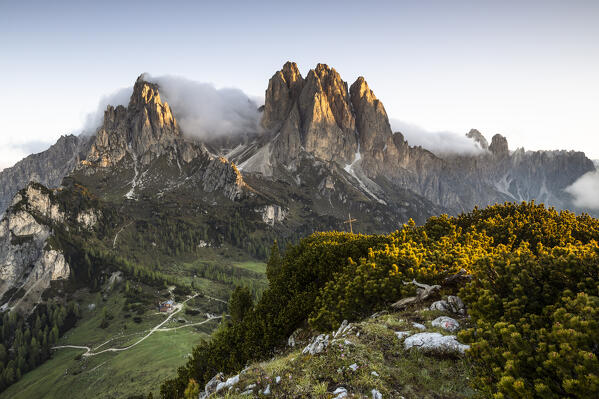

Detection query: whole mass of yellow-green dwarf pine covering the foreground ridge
xmin=161 ymin=203 xmax=599 ymax=398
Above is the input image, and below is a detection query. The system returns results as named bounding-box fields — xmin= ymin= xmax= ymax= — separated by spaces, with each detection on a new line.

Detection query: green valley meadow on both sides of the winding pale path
xmin=0 ymin=283 xmax=226 ymax=399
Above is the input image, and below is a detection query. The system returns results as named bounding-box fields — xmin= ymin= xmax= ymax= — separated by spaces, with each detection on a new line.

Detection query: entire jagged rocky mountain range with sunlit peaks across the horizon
xmin=0 ymin=62 xmax=595 ymax=221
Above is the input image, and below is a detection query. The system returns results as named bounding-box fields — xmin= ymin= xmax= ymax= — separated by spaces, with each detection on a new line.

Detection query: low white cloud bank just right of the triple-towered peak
xmin=389 ymin=119 xmax=484 ymax=155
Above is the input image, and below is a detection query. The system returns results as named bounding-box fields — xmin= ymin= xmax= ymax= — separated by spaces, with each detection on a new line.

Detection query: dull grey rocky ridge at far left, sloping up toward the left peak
xmin=0 ymin=135 xmax=90 ymax=215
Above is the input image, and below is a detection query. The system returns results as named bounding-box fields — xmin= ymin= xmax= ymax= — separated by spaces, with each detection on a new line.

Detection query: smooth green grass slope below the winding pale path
xmin=0 ymin=328 xmax=211 ymax=399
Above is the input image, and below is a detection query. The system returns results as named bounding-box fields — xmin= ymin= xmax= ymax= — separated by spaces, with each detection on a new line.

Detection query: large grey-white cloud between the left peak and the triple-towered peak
xmin=146 ymin=76 xmax=260 ymax=139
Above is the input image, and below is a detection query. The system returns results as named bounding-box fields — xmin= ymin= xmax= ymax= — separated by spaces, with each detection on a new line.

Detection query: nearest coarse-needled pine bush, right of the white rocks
xmin=461 ymin=242 xmax=599 ymax=398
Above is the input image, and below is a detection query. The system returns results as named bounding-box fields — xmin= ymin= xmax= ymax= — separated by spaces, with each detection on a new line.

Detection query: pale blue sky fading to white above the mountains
xmin=0 ymin=0 xmax=599 ymax=168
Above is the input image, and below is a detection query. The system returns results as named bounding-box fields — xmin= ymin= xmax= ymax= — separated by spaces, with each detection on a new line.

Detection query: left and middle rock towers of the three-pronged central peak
xmin=262 ymin=62 xmax=358 ymax=163
